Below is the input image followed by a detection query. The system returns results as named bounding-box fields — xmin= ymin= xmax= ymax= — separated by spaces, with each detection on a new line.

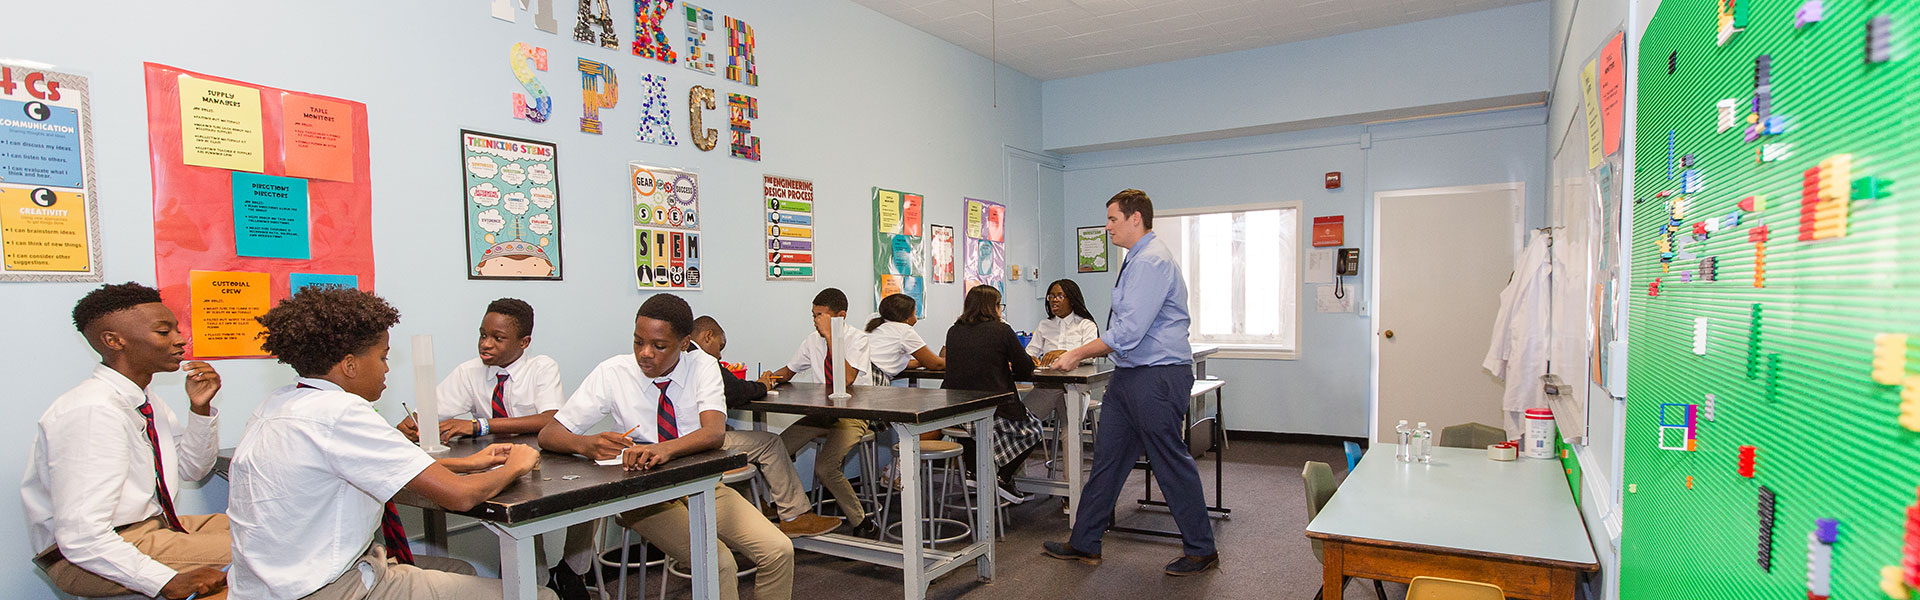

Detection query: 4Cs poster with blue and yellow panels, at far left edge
xmin=0 ymin=63 xmax=100 ymax=281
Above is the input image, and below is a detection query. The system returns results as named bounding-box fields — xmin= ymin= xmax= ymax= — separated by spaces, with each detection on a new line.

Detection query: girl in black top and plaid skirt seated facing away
xmin=941 ymin=285 xmax=1041 ymax=504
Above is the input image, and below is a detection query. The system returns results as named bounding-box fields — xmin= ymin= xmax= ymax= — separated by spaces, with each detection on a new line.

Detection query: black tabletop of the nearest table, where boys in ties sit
xmin=394 ymin=435 xmax=747 ymax=525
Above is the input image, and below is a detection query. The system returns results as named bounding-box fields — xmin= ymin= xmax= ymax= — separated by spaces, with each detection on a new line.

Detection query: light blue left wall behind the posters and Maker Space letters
xmin=0 ymin=0 xmax=1044 ymax=598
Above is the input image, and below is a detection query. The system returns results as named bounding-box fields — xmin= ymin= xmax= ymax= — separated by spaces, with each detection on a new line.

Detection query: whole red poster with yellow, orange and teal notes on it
xmin=146 ymin=63 xmax=374 ymax=358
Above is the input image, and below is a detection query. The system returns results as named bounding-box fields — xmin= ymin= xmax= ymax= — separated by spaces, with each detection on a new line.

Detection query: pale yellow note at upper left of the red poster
xmin=180 ymin=77 xmax=265 ymax=173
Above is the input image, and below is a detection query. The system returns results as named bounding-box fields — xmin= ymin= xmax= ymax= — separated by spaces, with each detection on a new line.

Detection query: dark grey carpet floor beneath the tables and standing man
xmin=609 ymin=440 xmax=1405 ymax=600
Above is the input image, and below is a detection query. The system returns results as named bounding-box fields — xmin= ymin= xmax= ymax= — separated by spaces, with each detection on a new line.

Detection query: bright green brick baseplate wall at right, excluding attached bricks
xmin=1620 ymin=0 xmax=1920 ymax=600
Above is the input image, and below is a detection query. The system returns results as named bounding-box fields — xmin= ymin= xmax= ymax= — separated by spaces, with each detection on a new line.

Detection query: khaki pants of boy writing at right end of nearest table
xmin=614 ymin=485 xmax=793 ymax=600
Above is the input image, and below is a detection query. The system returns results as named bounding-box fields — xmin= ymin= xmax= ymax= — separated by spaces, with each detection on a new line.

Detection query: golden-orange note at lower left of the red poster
xmin=188 ymin=271 xmax=271 ymax=358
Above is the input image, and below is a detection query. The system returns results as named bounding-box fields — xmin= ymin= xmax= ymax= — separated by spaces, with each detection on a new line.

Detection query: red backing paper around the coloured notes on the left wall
xmin=146 ymin=63 xmax=374 ymax=358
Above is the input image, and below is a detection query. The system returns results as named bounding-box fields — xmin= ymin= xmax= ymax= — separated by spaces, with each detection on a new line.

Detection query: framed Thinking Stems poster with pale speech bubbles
xmin=461 ymin=131 xmax=564 ymax=281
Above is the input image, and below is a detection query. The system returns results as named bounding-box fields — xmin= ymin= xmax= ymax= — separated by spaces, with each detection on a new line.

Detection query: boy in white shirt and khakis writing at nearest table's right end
xmin=540 ymin=294 xmax=793 ymax=600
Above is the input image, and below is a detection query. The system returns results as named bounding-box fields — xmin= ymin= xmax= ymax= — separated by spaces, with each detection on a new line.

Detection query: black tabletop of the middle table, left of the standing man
xmin=747 ymin=383 xmax=1014 ymax=423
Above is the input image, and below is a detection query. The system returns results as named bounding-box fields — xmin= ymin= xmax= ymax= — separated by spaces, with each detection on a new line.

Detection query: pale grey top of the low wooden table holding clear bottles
xmin=1308 ymin=444 xmax=1596 ymax=569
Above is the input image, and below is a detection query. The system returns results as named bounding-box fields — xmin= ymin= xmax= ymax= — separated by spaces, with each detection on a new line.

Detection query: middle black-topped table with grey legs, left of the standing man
xmin=747 ymin=383 xmax=1012 ymax=600
